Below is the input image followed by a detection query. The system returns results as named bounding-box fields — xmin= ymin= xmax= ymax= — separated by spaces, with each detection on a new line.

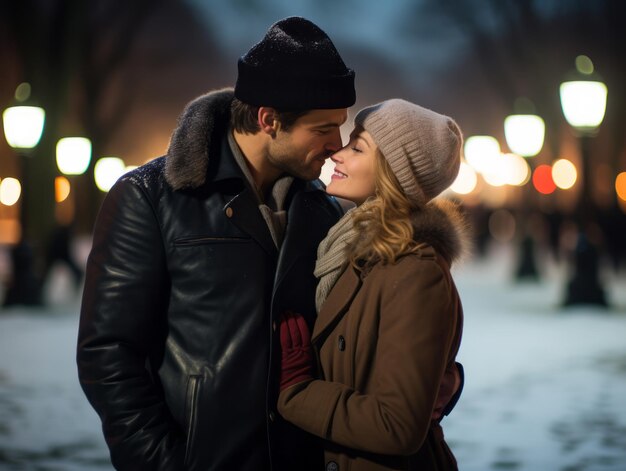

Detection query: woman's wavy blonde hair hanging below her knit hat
xmin=348 ymin=149 xmax=417 ymax=268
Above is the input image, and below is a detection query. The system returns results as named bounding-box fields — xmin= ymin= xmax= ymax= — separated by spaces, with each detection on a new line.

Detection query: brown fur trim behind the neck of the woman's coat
xmin=411 ymin=198 xmax=471 ymax=265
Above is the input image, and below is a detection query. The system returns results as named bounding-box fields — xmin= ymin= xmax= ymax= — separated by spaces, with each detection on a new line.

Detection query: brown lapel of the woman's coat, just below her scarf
xmin=311 ymin=265 xmax=362 ymax=343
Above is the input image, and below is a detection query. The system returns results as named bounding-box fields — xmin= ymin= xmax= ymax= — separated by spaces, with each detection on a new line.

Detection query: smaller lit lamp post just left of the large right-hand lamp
xmin=504 ymin=108 xmax=546 ymax=280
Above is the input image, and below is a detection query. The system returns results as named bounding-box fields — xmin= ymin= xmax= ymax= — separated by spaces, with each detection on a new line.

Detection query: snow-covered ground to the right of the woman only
xmin=444 ymin=249 xmax=626 ymax=471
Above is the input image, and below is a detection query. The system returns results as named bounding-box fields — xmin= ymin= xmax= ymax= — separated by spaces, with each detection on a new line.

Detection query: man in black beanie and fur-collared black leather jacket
xmin=77 ymin=17 xmax=355 ymax=471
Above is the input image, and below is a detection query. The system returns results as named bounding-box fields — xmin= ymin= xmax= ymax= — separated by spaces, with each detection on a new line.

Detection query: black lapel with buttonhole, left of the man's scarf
xmin=224 ymin=186 xmax=278 ymax=257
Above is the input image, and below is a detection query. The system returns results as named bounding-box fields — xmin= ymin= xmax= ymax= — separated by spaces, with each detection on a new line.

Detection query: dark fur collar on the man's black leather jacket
xmin=165 ymin=88 xmax=234 ymax=190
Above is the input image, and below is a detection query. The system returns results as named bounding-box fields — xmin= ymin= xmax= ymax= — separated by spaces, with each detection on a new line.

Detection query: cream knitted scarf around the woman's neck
xmin=313 ymin=208 xmax=358 ymax=313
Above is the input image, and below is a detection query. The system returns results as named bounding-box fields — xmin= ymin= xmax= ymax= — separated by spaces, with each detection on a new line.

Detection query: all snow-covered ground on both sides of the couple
xmin=0 ymin=248 xmax=626 ymax=471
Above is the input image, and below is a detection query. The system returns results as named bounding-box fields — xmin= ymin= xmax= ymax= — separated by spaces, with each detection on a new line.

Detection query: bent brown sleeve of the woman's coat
xmin=278 ymin=260 xmax=456 ymax=455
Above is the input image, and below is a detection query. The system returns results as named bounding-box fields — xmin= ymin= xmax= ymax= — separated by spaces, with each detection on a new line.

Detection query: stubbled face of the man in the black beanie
xmin=268 ymin=108 xmax=348 ymax=180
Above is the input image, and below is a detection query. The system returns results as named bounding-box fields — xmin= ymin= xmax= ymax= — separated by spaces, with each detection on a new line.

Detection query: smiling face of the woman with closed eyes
xmin=326 ymin=126 xmax=378 ymax=205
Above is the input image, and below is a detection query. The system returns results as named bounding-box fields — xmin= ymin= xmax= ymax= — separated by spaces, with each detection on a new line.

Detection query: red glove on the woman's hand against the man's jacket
xmin=280 ymin=311 xmax=313 ymax=391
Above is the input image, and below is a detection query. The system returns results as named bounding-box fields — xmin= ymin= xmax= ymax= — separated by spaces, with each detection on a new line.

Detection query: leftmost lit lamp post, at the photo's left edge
xmin=2 ymin=106 xmax=45 ymax=305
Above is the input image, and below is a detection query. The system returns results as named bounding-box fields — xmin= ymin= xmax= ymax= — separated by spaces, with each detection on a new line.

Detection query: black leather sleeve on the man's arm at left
xmin=77 ymin=179 xmax=184 ymax=470
